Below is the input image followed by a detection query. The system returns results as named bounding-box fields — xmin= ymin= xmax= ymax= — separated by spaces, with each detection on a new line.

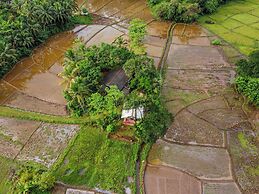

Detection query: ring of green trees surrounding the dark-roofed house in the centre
xmin=62 ymin=20 xmax=171 ymax=143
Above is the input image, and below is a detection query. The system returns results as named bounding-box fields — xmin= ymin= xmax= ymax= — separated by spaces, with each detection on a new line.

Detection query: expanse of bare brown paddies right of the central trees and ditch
xmin=145 ymin=24 xmax=258 ymax=194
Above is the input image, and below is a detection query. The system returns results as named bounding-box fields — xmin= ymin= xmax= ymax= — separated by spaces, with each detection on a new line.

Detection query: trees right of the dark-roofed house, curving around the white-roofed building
xmin=123 ymin=55 xmax=171 ymax=143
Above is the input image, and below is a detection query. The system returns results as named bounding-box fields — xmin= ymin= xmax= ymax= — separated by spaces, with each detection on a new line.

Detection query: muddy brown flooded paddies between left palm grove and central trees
xmin=0 ymin=32 xmax=75 ymax=113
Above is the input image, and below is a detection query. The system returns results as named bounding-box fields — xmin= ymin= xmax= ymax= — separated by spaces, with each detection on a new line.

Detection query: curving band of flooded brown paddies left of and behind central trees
xmin=0 ymin=0 xmax=170 ymax=115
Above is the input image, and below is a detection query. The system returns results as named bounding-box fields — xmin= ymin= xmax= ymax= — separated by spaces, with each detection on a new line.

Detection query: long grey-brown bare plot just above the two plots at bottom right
xmin=148 ymin=140 xmax=232 ymax=180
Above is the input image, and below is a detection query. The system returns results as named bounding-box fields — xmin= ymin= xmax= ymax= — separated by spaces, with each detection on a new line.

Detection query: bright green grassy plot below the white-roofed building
xmin=53 ymin=126 xmax=139 ymax=193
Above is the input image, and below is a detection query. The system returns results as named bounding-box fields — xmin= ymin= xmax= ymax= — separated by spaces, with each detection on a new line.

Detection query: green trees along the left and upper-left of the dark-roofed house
xmin=62 ymin=42 xmax=132 ymax=116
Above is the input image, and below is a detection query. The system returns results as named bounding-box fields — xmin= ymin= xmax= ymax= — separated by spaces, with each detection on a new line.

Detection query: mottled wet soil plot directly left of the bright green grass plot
xmin=17 ymin=123 xmax=78 ymax=167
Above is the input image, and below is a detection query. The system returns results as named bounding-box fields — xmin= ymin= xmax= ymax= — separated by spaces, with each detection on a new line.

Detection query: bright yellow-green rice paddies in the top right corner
xmin=199 ymin=0 xmax=259 ymax=55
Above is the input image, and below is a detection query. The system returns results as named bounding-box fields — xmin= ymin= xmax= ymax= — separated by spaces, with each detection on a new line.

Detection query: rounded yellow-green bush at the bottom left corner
xmin=13 ymin=163 xmax=55 ymax=193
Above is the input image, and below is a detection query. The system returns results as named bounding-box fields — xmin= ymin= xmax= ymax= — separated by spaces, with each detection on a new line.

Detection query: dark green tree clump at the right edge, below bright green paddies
xmin=235 ymin=50 xmax=259 ymax=107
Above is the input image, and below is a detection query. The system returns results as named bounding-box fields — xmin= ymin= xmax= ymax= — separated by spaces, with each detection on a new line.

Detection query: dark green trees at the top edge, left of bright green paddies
xmin=148 ymin=0 xmax=232 ymax=23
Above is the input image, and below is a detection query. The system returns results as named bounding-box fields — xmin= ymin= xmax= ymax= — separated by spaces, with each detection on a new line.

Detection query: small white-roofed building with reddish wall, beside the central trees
xmin=121 ymin=106 xmax=144 ymax=126
